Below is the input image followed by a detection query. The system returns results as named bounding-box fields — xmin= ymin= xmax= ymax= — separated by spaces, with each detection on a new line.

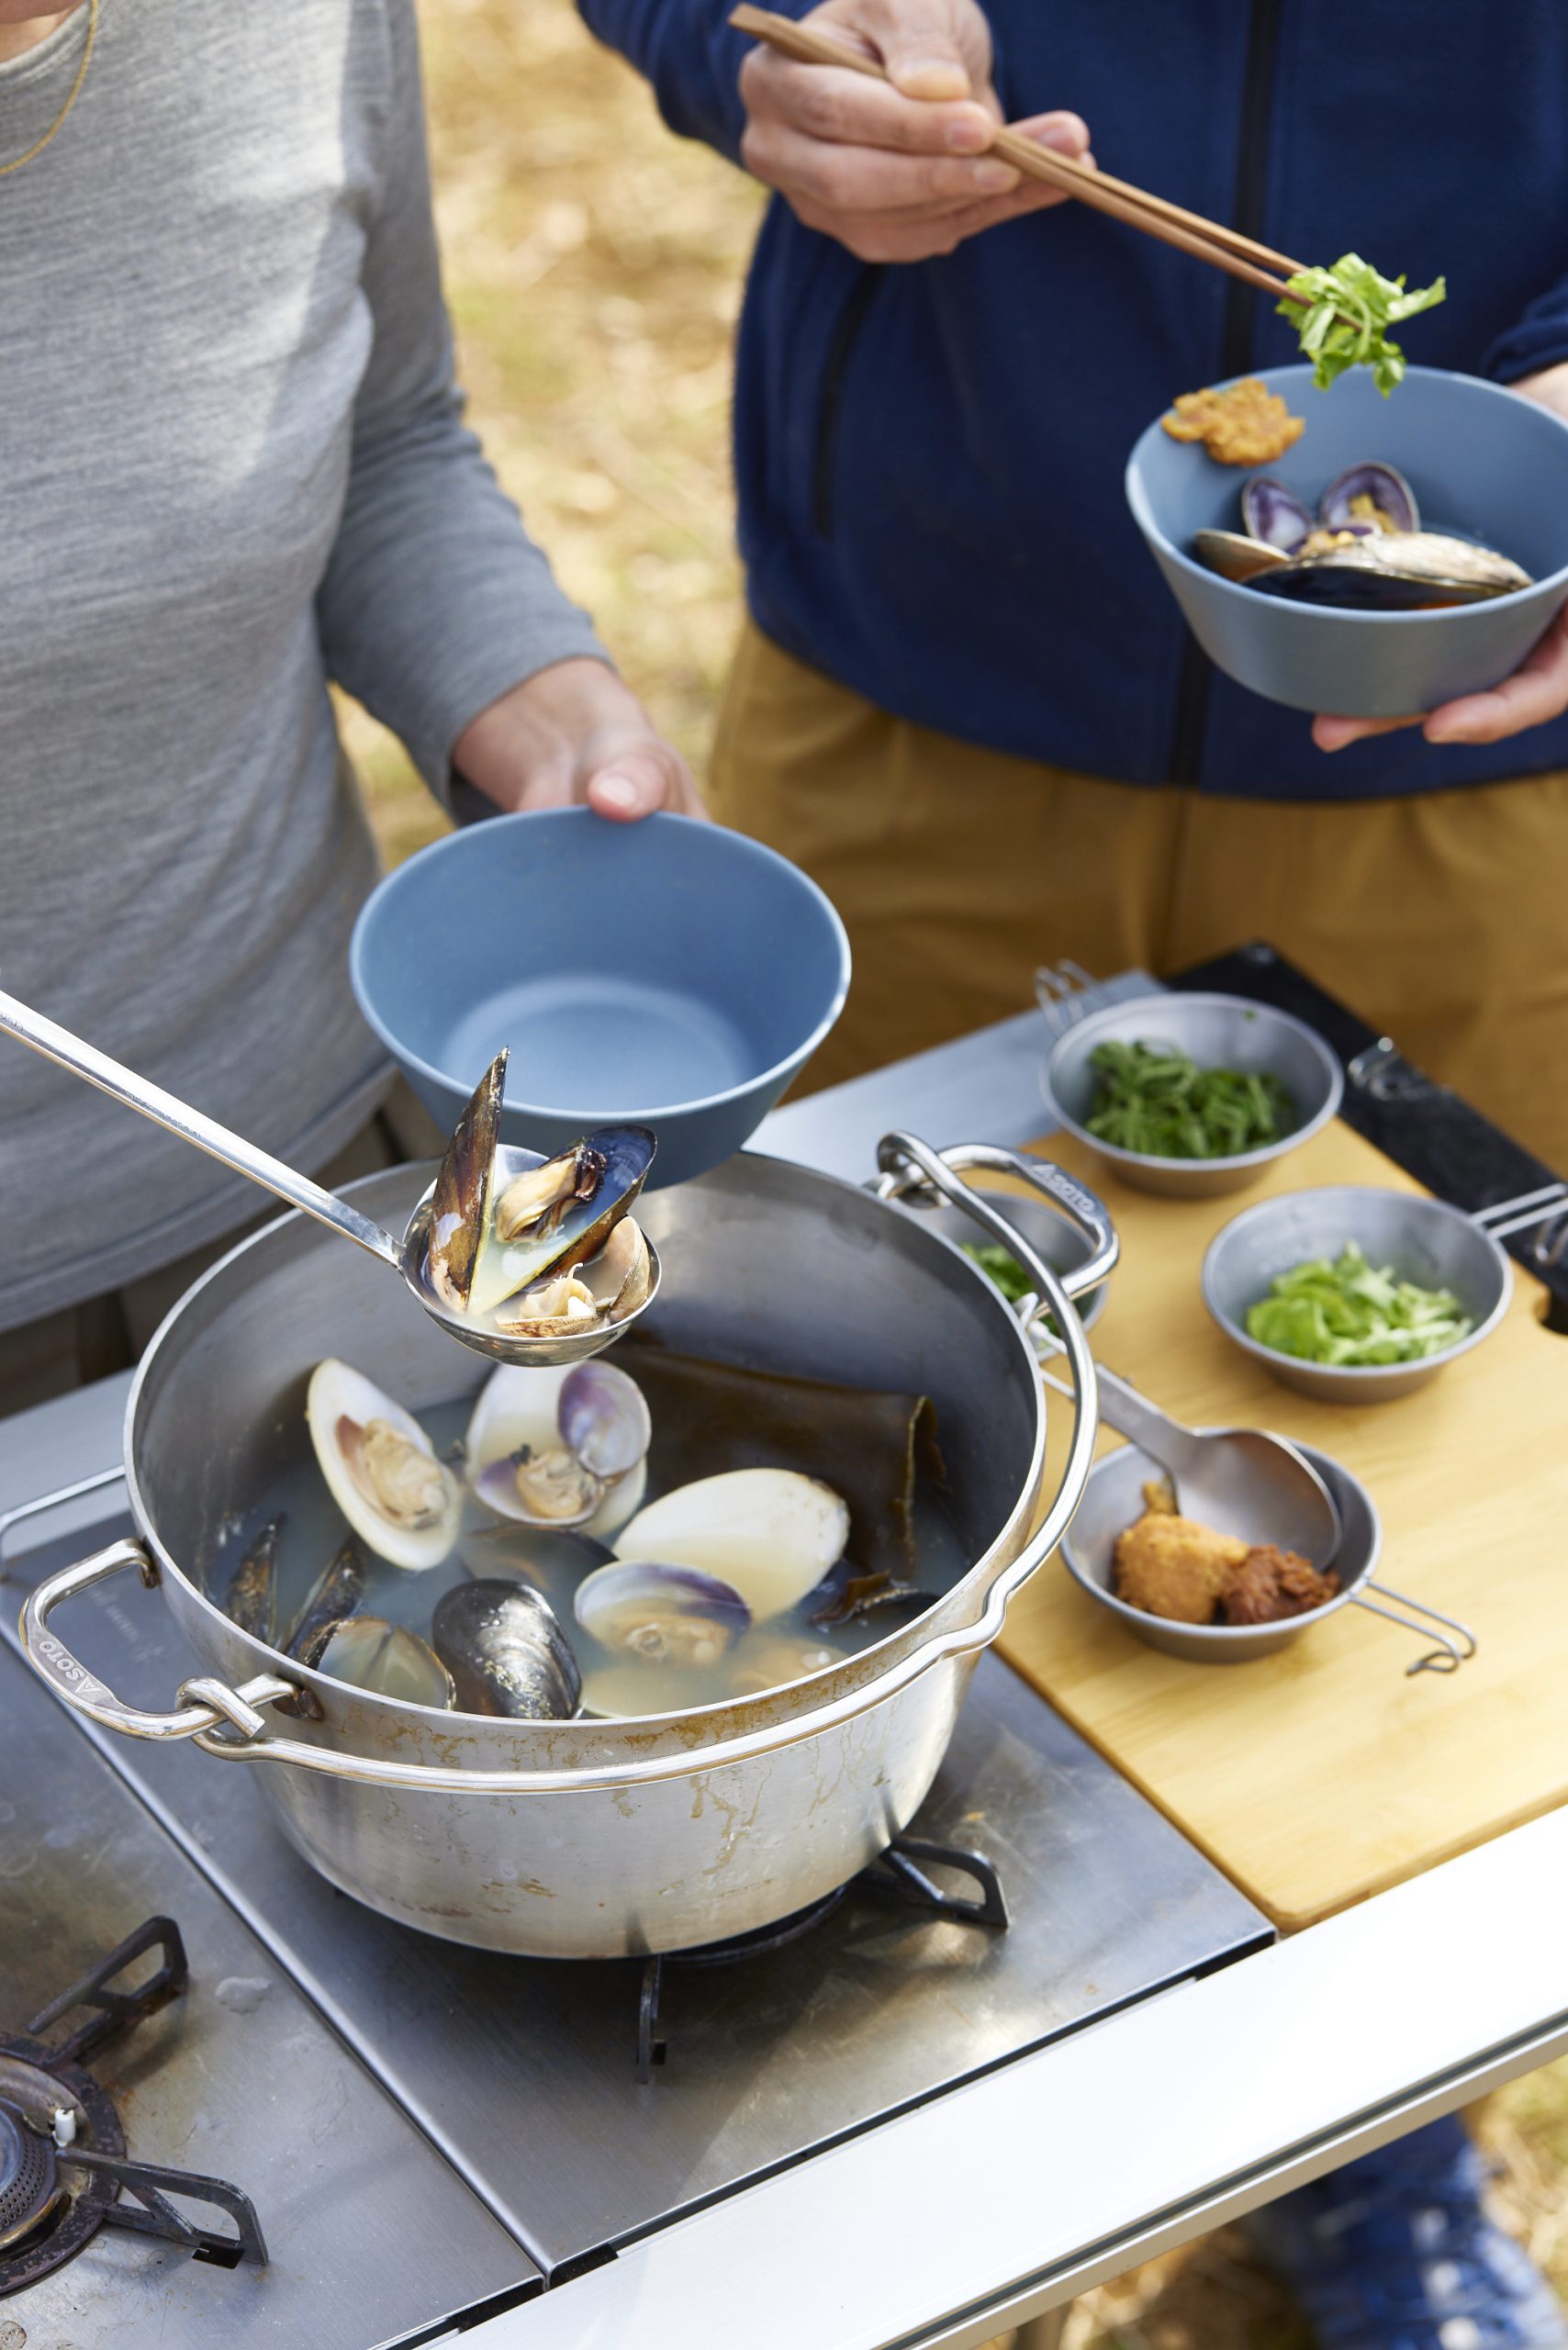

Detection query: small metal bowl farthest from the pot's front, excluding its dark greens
xmin=1039 ymin=991 xmax=1345 ymax=1199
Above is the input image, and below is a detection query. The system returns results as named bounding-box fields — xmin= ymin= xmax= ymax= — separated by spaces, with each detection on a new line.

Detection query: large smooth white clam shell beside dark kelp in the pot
xmin=613 ymin=1469 xmax=848 ymax=1624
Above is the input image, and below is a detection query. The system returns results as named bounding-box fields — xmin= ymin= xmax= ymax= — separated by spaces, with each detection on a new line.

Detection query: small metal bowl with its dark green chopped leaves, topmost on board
xmin=1041 ymin=994 xmax=1342 ymax=1196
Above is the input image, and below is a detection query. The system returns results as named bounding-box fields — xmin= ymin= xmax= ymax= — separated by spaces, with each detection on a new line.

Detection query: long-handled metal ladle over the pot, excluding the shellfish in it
xmin=0 ymin=990 xmax=658 ymax=1365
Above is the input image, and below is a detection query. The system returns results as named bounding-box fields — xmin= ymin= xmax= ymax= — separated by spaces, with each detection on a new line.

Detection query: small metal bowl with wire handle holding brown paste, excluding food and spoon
xmin=1062 ymin=1428 xmax=1476 ymax=1673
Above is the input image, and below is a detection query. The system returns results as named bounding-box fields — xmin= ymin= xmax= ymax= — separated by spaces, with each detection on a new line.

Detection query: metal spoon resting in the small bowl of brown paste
xmin=1041 ymin=1335 xmax=1342 ymax=1574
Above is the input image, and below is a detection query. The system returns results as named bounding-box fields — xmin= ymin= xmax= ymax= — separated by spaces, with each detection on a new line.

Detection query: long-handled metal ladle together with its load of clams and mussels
xmin=0 ymin=990 xmax=658 ymax=1365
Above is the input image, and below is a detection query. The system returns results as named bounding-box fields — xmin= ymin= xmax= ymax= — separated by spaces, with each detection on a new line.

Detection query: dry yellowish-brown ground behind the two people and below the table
xmin=375 ymin=0 xmax=1568 ymax=2350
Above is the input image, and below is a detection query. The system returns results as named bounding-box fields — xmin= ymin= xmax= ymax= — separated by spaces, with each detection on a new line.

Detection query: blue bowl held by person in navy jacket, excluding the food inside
xmin=1126 ymin=366 xmax=1568 ymax=719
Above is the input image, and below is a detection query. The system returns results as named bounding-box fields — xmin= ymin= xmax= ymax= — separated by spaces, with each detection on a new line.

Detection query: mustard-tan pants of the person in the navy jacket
xmin=710 ymin=622 xmax=1568 ymax=1170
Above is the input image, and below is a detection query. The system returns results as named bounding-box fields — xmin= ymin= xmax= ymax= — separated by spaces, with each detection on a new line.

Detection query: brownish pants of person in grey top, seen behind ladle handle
xmin=0 ymin=1081 xmax=444 ymax=1419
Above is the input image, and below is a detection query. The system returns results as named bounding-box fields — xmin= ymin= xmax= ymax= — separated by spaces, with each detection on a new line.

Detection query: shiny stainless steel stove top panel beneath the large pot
xmin=3 ymin=1537 xmax=1271 ymax=2273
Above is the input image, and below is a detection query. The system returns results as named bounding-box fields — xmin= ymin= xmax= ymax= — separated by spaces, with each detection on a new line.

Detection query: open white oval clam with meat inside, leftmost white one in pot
xmin=306 ymin=1356 xmax=463 ymax=1572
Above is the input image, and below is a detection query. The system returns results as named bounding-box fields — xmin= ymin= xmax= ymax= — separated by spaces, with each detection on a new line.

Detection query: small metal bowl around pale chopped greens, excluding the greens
xmin=1202 ymin=1184 xmax=1514 ymax=1403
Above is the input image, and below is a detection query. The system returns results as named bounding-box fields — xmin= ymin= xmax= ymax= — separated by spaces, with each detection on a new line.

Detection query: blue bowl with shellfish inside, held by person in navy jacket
xmin=1126 ymin=366 xmax=1568 ymax=719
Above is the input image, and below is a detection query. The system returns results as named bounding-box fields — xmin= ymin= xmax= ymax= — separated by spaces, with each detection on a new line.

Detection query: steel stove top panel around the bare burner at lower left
xmin=0 ymin=1635 xmax=541 ymax=2350
